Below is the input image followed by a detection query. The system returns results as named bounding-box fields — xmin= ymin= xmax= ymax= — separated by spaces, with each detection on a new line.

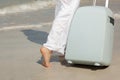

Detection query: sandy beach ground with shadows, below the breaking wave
xmin=0 ymin=0 xmax=120 ymax=80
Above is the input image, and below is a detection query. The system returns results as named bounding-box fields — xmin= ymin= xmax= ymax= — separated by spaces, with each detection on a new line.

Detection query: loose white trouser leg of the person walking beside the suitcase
xmin=43 ymin=0 xmax=80 ymax=54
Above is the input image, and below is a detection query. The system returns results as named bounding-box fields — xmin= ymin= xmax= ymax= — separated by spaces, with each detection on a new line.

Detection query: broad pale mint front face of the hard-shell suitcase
xmin=65 ymin=7 xmax=114 ymax=64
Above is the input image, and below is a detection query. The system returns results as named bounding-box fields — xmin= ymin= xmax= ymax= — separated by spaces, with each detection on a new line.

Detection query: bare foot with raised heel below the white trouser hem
xmin=40 ymin=47 xmax=52 ymax=68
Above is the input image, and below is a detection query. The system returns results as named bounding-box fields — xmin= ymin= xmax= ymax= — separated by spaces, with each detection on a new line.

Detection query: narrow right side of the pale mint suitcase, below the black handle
xmin=103 ymin=17 xmax=114 ymax=65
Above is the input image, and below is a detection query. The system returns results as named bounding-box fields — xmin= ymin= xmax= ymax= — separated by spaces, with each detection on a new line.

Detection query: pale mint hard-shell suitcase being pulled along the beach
xmin=65 ymin=0 xmax=114 ymax=66
